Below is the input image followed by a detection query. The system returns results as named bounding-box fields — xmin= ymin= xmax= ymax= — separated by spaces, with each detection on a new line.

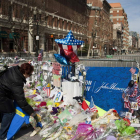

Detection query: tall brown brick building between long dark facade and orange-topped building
xmin=87 ymin=0 xmax=113 ymax=56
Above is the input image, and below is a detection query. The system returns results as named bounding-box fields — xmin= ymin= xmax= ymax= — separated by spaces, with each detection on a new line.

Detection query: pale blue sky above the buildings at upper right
xmin=107 ymin=0 xmax=140 ymax=33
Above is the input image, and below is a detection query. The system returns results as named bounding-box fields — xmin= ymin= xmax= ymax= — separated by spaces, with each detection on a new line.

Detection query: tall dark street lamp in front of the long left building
xmin=33 ymin=9 xmax=41 ymax=57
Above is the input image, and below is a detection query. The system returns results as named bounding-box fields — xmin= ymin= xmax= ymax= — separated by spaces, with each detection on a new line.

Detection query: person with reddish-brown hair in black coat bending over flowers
xmin=0 ymin=63 xmax=37 ymax=140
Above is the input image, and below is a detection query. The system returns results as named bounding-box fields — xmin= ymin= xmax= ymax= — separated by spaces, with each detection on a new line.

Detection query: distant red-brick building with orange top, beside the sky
xmin=110 ymin=3 xmax=129 ymax=52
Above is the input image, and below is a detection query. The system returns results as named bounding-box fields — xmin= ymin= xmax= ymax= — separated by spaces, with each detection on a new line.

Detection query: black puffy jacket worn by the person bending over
xmin=0 ymin=66 xmax=34 ymax=115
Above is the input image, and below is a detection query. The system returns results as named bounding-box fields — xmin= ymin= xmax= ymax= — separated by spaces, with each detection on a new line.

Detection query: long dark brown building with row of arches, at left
xmin=0 ymin=0 xmax=89 ymax=54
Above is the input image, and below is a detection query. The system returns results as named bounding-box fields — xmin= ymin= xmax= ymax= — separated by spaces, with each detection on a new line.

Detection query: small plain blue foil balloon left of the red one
xmin=54 ymin=54 xmax=69 ymax=65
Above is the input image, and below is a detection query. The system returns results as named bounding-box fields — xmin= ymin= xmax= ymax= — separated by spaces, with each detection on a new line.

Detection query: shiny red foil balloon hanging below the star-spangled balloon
xmin=64 ymin=49 xmax=80 ymax=63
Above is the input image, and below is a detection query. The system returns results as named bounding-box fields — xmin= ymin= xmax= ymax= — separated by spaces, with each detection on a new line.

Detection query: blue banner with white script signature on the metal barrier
xmin=86 ymin=67 xmax=138 ymax=113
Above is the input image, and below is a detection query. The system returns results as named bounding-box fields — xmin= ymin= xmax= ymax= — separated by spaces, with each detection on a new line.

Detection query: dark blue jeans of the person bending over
xmin=0 ymin=113 xmax=15 ymax=140
